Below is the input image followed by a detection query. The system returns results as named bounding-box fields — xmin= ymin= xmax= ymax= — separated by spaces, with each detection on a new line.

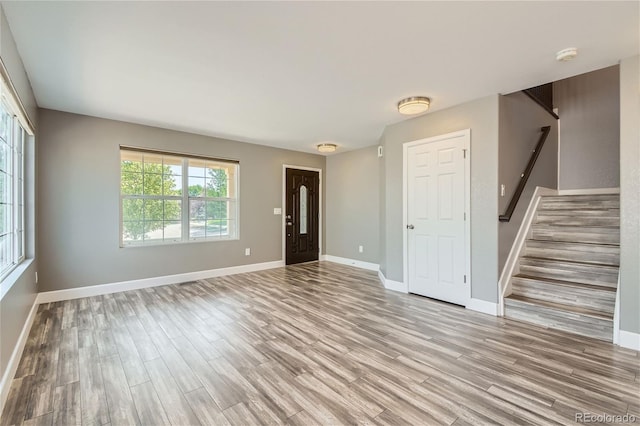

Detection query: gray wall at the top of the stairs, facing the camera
xmin=553 ymin=65 xmax=620 ymax=189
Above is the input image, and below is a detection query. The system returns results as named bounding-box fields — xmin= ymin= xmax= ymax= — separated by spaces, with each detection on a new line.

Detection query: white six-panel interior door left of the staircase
xmin=405 ymin=132 xmax=470 ymax=306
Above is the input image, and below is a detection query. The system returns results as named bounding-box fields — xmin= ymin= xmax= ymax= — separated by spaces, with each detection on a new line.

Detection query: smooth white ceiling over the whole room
xmin=2 ymin=1 xmax=640 ymax=152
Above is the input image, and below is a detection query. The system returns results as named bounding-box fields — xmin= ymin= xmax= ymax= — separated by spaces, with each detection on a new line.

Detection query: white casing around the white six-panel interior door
xmin=402 ymin=129 xmax=472 ymax=306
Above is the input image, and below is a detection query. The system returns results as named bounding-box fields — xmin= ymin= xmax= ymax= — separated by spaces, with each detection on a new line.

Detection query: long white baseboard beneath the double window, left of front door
xmin=36 ymin=260 xmax=285 ymax=303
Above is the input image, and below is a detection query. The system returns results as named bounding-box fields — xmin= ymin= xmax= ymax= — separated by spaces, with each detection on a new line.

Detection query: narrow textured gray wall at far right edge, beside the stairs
xmin=620 ymin=56 xmax=640 ymax=333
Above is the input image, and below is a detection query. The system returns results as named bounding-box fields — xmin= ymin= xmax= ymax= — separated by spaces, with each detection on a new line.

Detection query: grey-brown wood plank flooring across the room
xmin=0 ymin=262 xmax=640 ymax=426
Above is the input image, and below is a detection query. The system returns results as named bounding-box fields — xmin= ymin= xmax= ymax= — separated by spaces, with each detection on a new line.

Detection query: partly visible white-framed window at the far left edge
xmin=0 ymin=100 xmax=27 ymax=279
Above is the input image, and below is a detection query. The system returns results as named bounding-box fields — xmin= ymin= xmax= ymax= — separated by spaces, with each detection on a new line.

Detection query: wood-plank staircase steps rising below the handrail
xmin=505 ymin=194 xmax=620 ymax=342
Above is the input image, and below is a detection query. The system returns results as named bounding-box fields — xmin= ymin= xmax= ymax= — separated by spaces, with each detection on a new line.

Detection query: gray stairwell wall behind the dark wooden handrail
xmin=498 ymin=92 xmax=558 ymax=271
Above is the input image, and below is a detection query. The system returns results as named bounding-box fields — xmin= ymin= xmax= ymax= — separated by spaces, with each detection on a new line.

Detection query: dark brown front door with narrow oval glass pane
xmin=285 ymin=169 xmax=320 ymax=265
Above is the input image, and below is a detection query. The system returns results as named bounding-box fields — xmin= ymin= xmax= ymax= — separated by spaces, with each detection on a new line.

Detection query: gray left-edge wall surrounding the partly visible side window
xmin=0 ymin=8 xmax=38 ymax=388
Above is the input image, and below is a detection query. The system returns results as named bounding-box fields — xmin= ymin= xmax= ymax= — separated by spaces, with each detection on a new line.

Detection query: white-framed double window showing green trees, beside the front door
xmin=120 ymin=147 xmax=238 ymax=247
